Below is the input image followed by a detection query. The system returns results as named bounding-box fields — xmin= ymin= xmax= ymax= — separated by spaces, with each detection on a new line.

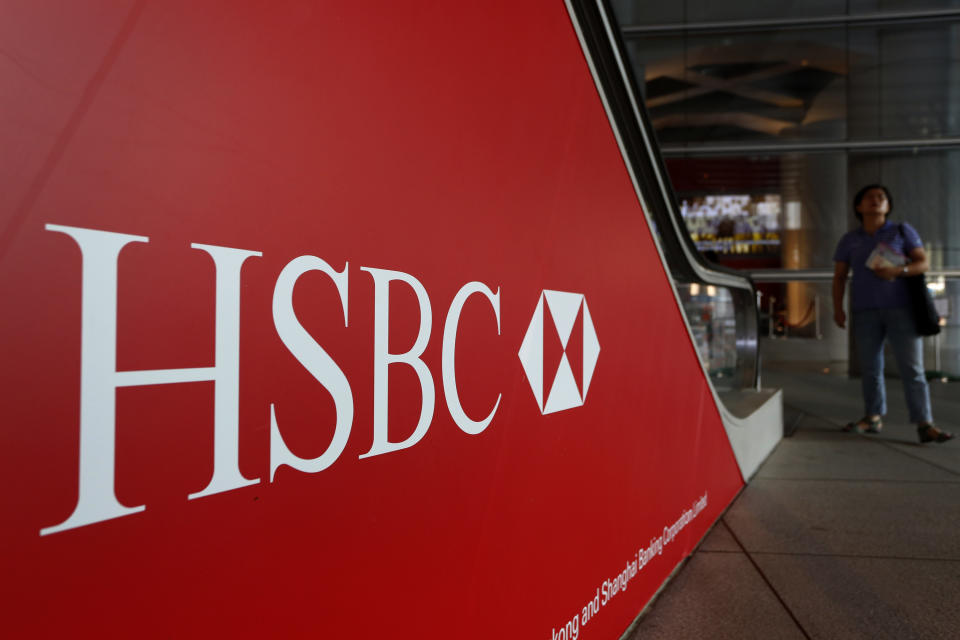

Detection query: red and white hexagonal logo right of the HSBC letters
xmin=518 ymin=290 xmax=600 ymax=415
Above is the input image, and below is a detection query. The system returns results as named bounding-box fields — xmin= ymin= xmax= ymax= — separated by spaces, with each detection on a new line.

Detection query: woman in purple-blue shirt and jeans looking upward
xmin=833 ymin=184 xmax=953 ymax=442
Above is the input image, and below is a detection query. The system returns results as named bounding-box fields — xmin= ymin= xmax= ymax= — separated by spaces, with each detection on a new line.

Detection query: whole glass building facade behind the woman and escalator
xmin=613 ymin=0 xmax=960 ymax=373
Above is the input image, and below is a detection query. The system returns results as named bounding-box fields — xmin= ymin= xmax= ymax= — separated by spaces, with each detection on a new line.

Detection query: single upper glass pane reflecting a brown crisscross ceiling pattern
xmin=629 ymin=28 xmax=848 ymax=144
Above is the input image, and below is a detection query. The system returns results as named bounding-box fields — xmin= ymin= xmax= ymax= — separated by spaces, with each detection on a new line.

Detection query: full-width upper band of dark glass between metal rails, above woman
xmin=627 ymin=21 xmax=960 ymax=145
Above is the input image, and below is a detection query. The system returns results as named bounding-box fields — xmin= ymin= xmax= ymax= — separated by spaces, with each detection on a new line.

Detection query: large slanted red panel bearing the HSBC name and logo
xmin=0 ymin=0 xmax=742 ymax=640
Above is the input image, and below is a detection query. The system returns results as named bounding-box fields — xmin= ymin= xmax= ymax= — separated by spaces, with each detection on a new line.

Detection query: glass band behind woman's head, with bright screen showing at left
xmin=666 ymin=149 xmax=960 ymax=270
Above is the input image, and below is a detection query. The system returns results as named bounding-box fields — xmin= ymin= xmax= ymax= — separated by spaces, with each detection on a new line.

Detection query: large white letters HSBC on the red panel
xmin=40 ymin=224 xmax=502 ymax=535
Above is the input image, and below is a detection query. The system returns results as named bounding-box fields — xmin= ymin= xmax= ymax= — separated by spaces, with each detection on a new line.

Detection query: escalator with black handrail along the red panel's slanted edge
xmin=570 ymin=0 xmax=783 ymax=478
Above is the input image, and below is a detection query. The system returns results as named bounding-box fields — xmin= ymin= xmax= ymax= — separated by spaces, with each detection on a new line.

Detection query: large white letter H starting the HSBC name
xmin=40 ymin=224 xmax=262 ymax=536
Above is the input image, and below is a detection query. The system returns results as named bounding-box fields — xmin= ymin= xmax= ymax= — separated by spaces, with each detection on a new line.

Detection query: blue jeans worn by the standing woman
xmin=853 ymin=307 xmax=933 ymax=423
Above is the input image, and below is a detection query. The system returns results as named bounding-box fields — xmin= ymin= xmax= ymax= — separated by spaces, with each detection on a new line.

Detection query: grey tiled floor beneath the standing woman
xmin=629 ymin=366 xmax=960 ymax=640
